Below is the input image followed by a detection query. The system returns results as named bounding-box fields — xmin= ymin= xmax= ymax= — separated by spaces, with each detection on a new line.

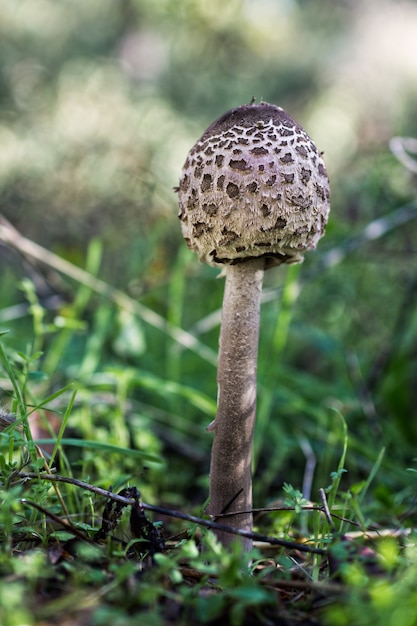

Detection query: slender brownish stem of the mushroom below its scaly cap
xmin=209 ymin=258 xmax=265 ymax=550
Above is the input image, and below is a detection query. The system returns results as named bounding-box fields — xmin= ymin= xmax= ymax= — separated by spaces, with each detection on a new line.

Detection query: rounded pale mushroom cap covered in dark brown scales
xmin=179 ymin=102 xmax=330 ymax=267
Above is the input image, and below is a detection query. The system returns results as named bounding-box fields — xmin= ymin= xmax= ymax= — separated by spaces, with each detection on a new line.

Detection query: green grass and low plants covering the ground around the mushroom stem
xmin=0 ymin=217 xmax=417 ymax=626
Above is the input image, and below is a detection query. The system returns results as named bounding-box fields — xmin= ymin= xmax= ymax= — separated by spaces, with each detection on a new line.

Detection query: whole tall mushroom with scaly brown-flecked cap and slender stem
xmin=179 ymin=102 xmax=330 ymax=549
